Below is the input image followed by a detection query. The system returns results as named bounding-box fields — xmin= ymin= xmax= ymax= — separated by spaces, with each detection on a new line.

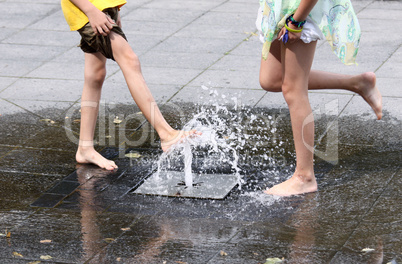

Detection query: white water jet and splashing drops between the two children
xmin=158 ymin=86 xmax=287 ymax=193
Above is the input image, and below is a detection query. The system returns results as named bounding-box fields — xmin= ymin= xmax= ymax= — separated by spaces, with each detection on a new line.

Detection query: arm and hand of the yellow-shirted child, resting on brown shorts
xmin=70 ymin=0 xmax=115 ymax=36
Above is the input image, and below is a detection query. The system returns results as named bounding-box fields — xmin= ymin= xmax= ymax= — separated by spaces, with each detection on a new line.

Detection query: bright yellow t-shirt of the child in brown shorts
xmin=61 ymin=0 xmax=127 ymax=31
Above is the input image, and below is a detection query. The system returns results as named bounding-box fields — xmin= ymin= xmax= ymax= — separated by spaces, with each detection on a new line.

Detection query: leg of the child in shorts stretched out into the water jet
xmin=109 ymin=32 xmax=197 ymax=151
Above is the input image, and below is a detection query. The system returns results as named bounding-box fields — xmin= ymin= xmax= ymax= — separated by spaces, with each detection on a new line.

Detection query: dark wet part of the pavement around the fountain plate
xmin=0 ymin=105 xmax=402 ymax=264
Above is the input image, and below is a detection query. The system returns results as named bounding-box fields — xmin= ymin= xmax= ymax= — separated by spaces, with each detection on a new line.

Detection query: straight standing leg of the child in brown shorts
xmin=76 ymin=53 xmax=117 ymax=170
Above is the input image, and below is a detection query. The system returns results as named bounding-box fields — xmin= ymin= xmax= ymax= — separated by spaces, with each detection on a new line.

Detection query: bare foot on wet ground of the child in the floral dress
xmin=264 ymin=173 xmax=317 ymax=196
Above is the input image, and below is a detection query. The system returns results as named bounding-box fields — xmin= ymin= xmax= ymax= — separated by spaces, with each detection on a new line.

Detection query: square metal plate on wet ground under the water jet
xmin=134 ymin=171 xmax=238 ymax=199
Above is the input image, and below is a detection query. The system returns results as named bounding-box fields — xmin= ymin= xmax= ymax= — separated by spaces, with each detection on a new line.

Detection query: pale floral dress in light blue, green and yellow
xmin=260 ymin=0 xmax=361 ymax=65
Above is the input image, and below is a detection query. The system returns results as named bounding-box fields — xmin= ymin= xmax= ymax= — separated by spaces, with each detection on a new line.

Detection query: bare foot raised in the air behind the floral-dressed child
xmin=358 ymin=72 xmax=382 ymax=120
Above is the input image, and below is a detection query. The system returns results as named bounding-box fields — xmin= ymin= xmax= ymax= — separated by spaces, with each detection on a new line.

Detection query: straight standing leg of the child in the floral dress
xmin=265 ymin=41 xmax=317 ymax=196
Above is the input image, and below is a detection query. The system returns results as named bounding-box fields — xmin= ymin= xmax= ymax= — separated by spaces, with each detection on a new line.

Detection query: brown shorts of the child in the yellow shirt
xmin=78 ymin=7 xmax=127 ymax=60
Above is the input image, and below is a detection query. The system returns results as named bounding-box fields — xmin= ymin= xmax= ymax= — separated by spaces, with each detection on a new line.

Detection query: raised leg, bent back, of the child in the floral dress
xmin=260 ymin=41 xmax=382 ymax=119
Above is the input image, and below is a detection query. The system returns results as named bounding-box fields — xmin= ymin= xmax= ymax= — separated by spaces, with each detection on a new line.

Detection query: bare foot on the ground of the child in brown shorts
xmin=75 ymin=146 xmax=117 ymax=170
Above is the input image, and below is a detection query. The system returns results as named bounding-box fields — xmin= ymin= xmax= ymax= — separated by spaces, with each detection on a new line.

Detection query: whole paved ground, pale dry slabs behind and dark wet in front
xmin=0 ymin=0 xmax=402 ymax=264
